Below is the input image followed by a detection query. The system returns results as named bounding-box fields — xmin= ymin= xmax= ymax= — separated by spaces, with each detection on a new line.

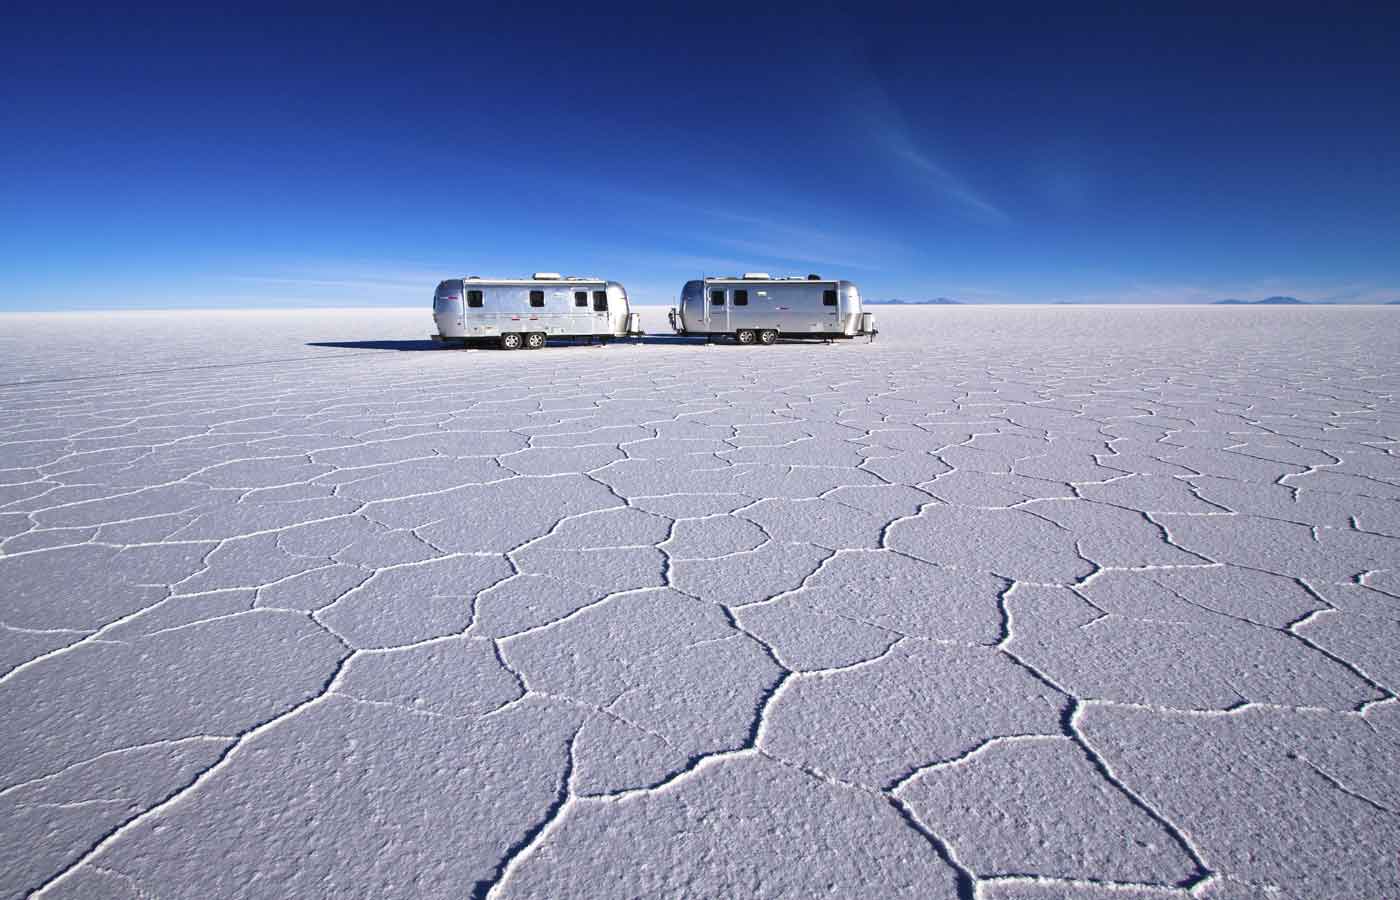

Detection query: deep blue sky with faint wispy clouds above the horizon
xmin=0 ymin=3 xmax=1400 ymax=309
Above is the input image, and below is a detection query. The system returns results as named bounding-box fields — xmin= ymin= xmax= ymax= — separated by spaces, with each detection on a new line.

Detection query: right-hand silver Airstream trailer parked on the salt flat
xmin=671 ymin=272 xmax=876 ymax=344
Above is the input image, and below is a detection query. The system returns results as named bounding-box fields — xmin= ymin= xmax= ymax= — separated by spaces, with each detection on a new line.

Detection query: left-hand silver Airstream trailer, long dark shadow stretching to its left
xmin=433 ymin=272 xmax=641 ymax=350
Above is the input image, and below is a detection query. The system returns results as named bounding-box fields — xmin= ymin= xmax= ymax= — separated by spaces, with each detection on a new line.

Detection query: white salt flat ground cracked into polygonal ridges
xmin=0 ymin=308 xmax=1400 ymax=900
